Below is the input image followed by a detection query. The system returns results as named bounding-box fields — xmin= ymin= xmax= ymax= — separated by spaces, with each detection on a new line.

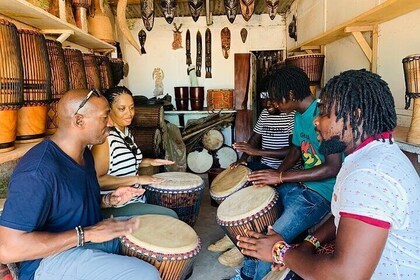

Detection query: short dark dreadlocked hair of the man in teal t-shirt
xmin=268 ymin=65 xmax=311 ymax=102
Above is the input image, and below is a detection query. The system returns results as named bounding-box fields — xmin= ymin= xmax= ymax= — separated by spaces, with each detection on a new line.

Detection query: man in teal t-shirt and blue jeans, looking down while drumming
xmin=231 ymin=66 xmax=343 ymax=280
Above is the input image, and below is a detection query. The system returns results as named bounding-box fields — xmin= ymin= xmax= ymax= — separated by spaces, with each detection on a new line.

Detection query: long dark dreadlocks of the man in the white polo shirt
xmin=320 ymin=69 xmax=397 ymax=143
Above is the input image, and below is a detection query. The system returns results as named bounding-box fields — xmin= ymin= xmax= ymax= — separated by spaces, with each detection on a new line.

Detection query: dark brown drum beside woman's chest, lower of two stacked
xmin=131 ymin=127 xmax=162 ymax=158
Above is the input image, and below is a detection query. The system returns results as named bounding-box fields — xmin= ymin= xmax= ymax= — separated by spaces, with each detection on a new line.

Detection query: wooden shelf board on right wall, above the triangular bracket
xmin=289 ymin=0 xmax=420 ymax=52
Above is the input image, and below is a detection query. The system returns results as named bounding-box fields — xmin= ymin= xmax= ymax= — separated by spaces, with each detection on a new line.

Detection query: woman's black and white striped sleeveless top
xmin=108 ymin=127 xmax=145 ymax=203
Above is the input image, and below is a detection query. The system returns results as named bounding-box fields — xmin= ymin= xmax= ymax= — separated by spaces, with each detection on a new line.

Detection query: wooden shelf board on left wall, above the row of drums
xmin=0 ymin=0 xmax=115 ymax=50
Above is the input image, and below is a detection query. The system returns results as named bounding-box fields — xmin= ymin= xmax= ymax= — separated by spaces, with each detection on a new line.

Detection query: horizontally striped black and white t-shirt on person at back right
xmin=254 ymin=109 xmax=295 ymax=169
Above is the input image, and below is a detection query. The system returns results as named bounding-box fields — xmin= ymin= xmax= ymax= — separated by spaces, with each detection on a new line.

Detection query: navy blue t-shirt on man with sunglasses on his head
xmin=0 ymin=140 xmax=102 ymax=280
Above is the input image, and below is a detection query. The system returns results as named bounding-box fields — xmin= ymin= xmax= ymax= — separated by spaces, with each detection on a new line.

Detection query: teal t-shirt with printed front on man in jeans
xmin=292 ymin=100 xmax=335 ymax=201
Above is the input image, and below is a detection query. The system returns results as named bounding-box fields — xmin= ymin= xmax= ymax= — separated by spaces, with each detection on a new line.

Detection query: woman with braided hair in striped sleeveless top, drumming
xmin=92 ymin=86 xmax=177 ymax=217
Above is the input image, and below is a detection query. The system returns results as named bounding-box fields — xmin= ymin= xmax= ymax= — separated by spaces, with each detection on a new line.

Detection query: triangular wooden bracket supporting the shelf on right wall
xmin=344 ymin=25 xmax=378 ymax=72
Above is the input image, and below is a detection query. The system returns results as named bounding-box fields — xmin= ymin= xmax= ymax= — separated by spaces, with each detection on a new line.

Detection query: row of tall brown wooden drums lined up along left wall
xmin=0 ymin=19 xmax=124 ymax=152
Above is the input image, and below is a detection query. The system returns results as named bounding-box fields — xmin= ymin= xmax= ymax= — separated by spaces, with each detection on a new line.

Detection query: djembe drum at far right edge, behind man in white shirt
xmin=402 ymin=54 xmax=420 ymax=144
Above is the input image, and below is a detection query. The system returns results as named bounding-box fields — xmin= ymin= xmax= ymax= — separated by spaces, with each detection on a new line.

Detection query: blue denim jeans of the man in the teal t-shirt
xmin=241 ymin=183 xmax=330 ymax=280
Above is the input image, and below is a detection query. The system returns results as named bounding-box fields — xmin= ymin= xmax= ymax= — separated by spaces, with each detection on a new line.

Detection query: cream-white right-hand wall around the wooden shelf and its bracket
xmin=286 ymin=0 xmax=420 ymax=126
